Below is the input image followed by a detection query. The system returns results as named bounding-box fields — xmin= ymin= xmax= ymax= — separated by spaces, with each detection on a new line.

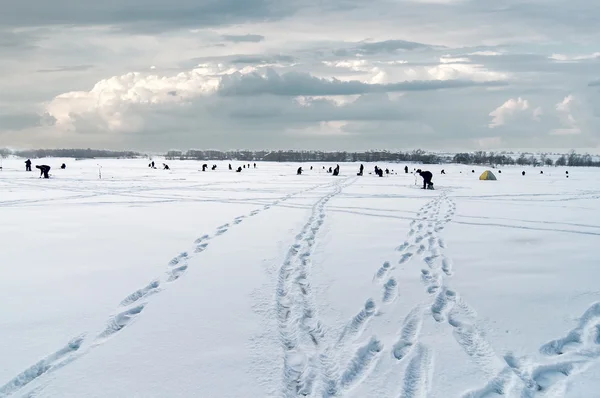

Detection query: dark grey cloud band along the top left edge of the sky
xmin=0 ymin=0 xmax=296 ymax=33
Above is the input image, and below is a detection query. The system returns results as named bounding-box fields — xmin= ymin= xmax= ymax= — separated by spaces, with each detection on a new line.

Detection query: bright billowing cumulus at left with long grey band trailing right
xmin=46 ymin=65 xmax=503 ymax=132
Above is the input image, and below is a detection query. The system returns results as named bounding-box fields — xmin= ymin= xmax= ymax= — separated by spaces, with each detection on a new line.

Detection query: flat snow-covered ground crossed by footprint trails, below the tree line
xmin=0 ymin=159 xmax=600 ymax=398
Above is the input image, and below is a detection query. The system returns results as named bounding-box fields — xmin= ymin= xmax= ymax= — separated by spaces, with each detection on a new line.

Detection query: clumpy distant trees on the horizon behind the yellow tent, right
xmin=452 ymin=151 xmax=600 ymax=167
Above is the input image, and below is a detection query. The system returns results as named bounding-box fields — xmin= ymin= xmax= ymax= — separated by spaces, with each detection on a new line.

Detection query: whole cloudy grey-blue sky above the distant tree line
xmin=0 ymin=0 xmax=600 ymax=153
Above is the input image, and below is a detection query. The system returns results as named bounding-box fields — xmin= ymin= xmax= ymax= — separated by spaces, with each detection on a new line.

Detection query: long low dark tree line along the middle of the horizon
xmin=165 ymin=149 xmax=442 ymax=164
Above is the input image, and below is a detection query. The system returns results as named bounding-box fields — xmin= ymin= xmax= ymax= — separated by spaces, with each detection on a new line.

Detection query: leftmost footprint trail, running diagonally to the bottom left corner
xmin=0 ymin=183 xmax=332 ymax=398
